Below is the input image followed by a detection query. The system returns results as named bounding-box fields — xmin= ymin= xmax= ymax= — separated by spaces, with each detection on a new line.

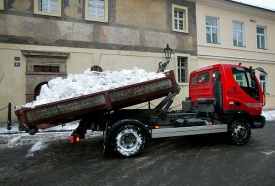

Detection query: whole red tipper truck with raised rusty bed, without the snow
xmin=15 ymin=64 xmax=266 ymax=157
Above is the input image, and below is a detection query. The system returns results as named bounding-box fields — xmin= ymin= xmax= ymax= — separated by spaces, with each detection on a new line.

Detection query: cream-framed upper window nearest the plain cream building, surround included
xmin=172 ymin=5 xmax=188 ymax=33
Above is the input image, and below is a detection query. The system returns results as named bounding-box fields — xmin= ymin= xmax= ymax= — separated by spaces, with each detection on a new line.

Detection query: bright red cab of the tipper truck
xmin=189 ymin=64 xmax=265 ymax=128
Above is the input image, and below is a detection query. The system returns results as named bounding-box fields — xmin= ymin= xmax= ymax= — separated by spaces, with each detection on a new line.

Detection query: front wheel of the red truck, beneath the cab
xmin=229 ymin=119 xmax=251 ymax=145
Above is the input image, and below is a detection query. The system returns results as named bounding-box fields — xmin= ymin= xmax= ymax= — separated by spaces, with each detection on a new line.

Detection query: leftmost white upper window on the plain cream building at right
xmin=206 ymin=17 xmax=219 ymax=43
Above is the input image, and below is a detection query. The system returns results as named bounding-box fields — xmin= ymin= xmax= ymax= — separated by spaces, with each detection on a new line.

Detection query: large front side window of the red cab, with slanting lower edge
xmin=232 ymin=67 xmax=260 ymax=100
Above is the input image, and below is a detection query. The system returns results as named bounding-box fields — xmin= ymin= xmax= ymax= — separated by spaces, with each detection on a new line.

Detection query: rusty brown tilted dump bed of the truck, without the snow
xmin=15 ymin=71 xmax=179 ymax=127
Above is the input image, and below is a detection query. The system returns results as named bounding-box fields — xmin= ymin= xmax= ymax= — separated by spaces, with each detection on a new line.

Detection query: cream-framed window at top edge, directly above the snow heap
xmin=85 ymin=0 xmax=108 ymax=22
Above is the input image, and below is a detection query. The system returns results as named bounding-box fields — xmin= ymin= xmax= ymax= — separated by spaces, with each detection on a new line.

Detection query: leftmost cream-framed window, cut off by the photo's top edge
xmin=34 ymin=0 xmax=61 ymax=17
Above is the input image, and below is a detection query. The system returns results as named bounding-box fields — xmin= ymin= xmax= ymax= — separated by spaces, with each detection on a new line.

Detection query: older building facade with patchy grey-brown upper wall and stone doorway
xmin=0 ymin=0 xmax=198 ymax=123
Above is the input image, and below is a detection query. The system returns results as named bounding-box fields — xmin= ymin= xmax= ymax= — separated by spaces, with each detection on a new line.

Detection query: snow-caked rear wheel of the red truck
xmin=111 ymin=125 xmax=145 ymax=157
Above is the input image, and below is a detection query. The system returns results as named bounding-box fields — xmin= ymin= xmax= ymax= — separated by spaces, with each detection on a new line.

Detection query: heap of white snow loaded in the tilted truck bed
xmin=17 ymin=67 xmax=165 ymax=109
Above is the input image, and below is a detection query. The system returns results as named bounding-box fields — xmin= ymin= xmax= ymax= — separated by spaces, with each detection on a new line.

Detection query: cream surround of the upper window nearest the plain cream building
xmin=172 ymin=4 xmax=189 ymax=33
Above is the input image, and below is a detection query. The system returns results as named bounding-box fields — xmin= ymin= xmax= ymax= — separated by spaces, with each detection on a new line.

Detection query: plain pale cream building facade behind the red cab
xmin=196 ymin=0 xmax=275 ymax=109
